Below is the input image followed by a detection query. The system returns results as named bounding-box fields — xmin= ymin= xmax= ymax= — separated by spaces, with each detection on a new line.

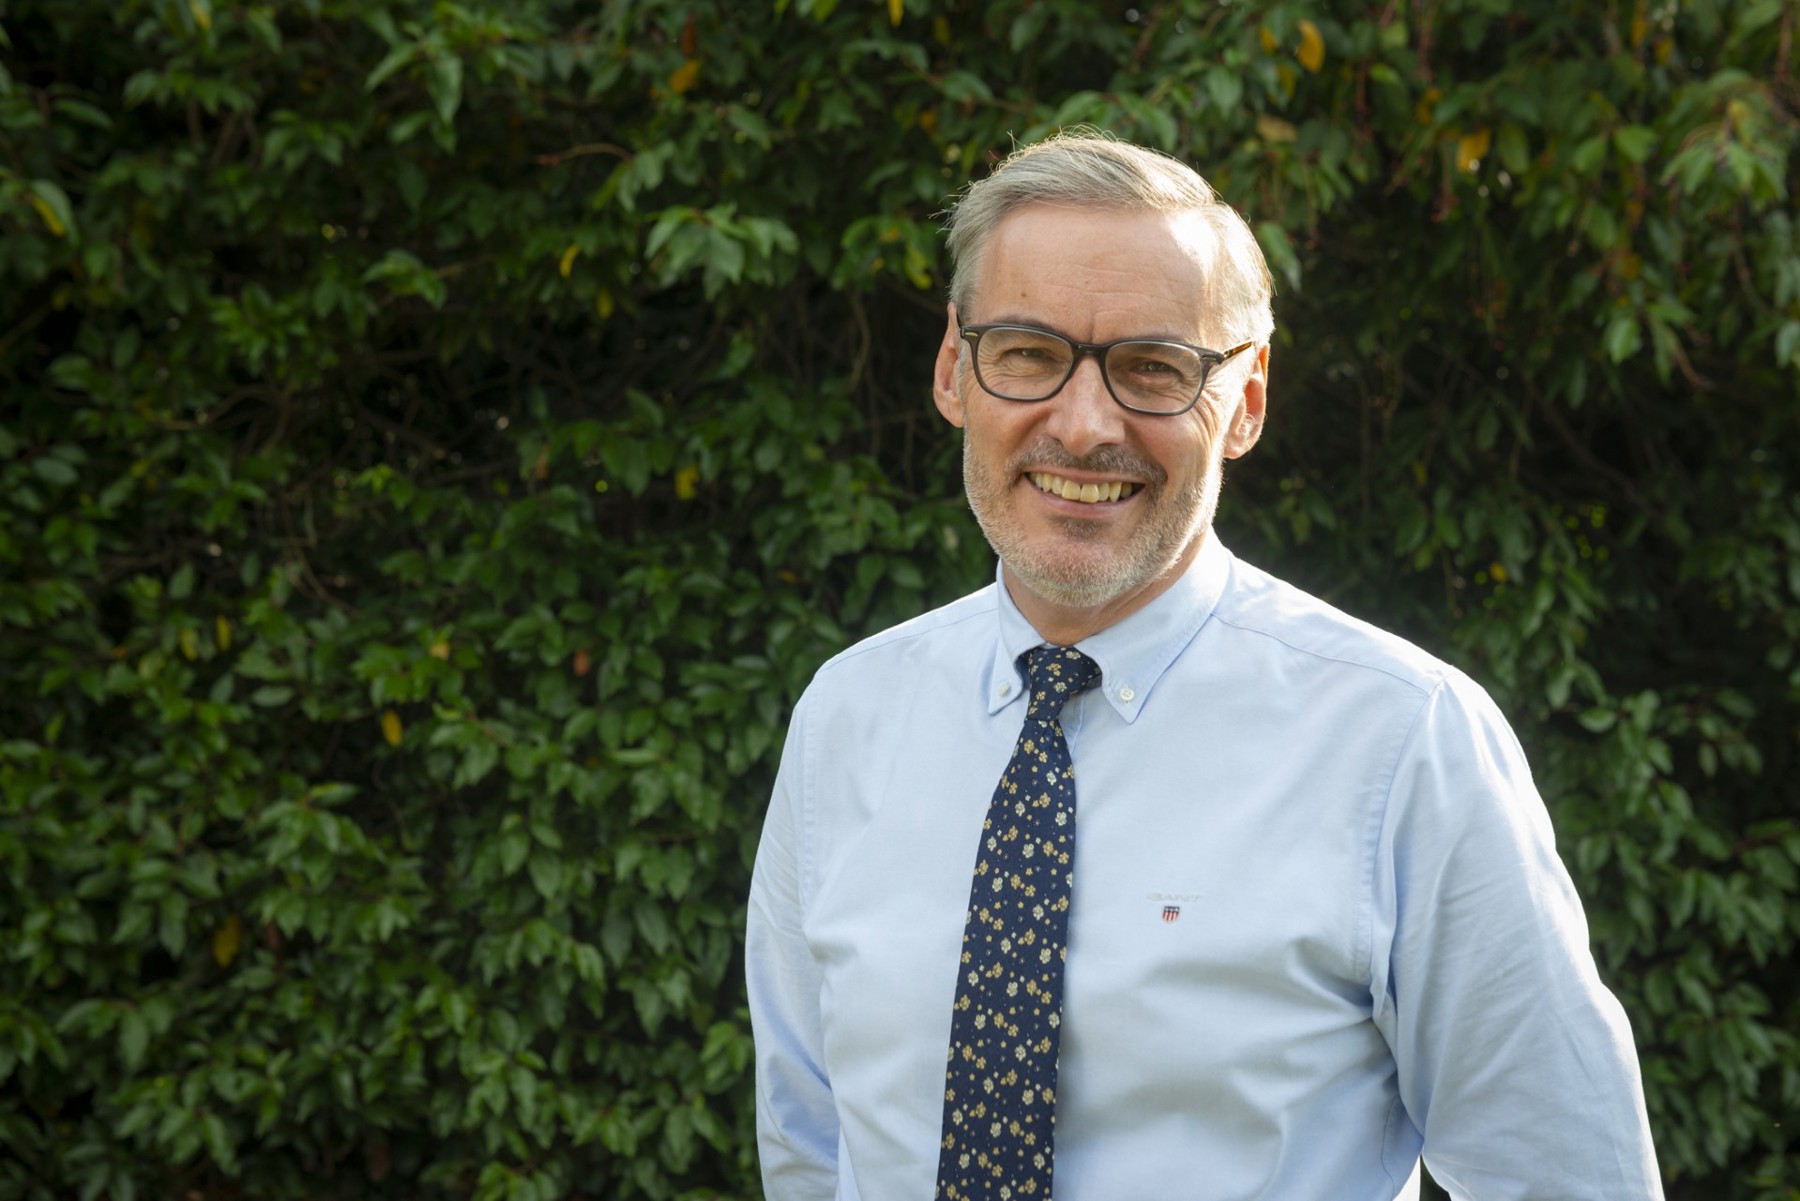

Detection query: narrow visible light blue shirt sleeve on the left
xmin=743 ymin=699 xmax=839 ymax=1201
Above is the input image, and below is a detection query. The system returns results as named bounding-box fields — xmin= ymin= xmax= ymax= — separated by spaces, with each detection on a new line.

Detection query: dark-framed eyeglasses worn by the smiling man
xmin=959 ymin=326 xmax=1255 ymax=418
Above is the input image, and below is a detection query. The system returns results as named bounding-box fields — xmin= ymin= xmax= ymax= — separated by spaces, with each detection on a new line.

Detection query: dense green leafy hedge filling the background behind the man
xmin=0 ymin=0 xmax=1800 ymax=1201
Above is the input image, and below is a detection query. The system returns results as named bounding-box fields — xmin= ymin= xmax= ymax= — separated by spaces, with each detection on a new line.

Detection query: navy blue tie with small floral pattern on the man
xmin=936 ymin=646 xmax=1100 ymax=1201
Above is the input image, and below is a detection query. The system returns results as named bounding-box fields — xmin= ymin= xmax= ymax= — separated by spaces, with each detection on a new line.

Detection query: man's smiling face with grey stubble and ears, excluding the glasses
xmin=934 ymin=205 xmax=1267 ymax=632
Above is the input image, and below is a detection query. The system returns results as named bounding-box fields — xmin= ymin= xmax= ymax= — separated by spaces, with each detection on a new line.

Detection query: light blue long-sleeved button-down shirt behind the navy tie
xmin=747 ymin=537 xmax=1661 ymax=1201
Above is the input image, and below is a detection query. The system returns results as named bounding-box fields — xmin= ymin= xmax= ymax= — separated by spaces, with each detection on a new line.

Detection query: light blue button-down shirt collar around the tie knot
xmin=986 ymin=529 xmax=1231 ymax=724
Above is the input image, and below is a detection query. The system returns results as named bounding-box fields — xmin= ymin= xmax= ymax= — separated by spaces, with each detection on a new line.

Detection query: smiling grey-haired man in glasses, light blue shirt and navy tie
xmin=747 ymin=135 xmax=1661 ymax=1201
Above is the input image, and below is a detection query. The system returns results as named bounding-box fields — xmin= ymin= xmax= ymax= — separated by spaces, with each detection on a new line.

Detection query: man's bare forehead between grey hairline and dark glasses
xmin=963 ymin=205 xmax=1213 ymax=342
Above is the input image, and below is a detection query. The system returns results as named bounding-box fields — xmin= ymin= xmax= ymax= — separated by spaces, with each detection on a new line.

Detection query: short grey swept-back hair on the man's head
xmin=947 ymin=130 xmax=1274 ymax=342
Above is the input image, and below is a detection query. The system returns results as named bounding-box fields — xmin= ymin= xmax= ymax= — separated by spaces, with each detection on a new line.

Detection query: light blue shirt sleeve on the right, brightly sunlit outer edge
xmin=1372 ymin=677 xmax=1663 ymax=1201
